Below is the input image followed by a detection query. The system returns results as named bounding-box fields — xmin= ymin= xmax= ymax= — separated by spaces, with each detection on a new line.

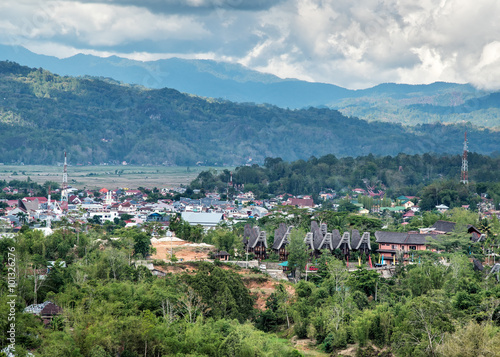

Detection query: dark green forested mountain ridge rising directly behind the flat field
xmin=0 ymin=62 xmax=500 ymax=165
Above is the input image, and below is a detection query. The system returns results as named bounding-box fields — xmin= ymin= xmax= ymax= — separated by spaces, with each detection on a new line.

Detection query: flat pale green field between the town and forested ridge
xmin=0 ymin=165 xmax=233 ymax=189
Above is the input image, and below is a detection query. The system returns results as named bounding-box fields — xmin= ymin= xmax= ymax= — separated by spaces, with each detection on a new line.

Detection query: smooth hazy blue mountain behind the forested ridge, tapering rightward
xmin=0 ymin=45 xmax=355 ymax=108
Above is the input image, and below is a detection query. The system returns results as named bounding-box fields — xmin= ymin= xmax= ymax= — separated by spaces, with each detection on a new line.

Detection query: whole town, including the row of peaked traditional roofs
xmin=0 ymin=154 xmax=500 ymax=271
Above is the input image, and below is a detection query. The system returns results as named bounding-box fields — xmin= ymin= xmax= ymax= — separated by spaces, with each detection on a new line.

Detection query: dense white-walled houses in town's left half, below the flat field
xmin=0 ymin=182 xmax=330 ymax=235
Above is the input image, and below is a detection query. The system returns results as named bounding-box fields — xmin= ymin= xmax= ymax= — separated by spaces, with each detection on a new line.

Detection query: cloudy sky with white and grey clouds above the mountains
xmin=0 ymin=0 xmax=500 ymax=89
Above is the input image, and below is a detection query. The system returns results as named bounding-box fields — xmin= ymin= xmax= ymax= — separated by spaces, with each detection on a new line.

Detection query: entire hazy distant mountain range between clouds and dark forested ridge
xmin=0 ymin=45 xmax=500 ymax=127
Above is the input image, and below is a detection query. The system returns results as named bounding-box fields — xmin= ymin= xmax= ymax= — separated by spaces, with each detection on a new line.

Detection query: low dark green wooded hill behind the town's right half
xmin=191 ymin=154 xmax=500 ymax=209
